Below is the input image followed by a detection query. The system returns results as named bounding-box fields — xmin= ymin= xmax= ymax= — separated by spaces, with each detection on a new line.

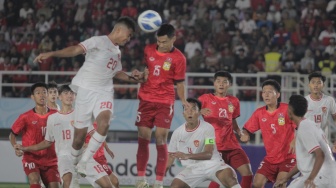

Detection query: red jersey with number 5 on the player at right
xmin=244 ymin=103 xmax=296 ymax=164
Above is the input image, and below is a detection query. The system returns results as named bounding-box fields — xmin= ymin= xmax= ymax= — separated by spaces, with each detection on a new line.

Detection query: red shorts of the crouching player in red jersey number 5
xmin=256 ymin=158 xmax=296 ymax=183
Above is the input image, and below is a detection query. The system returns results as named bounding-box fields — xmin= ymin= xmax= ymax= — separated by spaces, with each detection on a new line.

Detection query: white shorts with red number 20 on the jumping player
xmin=75 ymin=87 xmax=114 ymax=129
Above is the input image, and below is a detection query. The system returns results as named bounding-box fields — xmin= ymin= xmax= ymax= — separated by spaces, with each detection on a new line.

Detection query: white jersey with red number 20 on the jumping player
xmin=71 ymin=35 xmax=122 ymax=94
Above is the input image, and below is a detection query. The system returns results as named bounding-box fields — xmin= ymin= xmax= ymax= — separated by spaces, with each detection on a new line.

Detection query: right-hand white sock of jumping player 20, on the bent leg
xmin=81 ymin=131 xmax=106 ymax=162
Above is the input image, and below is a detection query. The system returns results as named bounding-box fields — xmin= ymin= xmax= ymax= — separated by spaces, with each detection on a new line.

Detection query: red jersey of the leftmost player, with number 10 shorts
xmin=12 ymin=109 xmax=57 ymax=166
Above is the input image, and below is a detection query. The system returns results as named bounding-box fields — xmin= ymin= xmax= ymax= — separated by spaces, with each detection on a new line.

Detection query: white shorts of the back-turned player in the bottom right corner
xmin=288 ymin=173 xmax=336 ymax=188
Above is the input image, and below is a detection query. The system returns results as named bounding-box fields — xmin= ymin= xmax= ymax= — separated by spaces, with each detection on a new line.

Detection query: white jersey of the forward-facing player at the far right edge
xmin=305 ymin=94 xmax=336 ymax=137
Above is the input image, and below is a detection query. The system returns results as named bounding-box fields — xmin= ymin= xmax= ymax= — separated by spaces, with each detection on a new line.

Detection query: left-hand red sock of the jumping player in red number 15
xmin=137 ymin=138 xmax=149 ymax=176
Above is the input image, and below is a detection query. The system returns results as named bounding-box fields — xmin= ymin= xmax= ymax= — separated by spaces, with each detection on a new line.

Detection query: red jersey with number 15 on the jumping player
xmin=138 ymin=44 xmax=186 ymax=104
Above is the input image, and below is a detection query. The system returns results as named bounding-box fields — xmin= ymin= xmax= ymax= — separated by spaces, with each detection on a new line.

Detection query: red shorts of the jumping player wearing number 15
xmin=135 ymin=100 xmax=174 ymax=129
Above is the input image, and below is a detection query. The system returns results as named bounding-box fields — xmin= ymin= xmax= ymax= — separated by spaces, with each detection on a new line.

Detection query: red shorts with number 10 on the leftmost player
xmin=22 ymin=161 xmax=61 ymax=184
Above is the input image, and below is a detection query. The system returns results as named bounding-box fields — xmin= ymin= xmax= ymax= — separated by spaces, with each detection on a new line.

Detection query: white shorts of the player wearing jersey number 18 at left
xmin=57 ymin=155 xmax=80 ymax=188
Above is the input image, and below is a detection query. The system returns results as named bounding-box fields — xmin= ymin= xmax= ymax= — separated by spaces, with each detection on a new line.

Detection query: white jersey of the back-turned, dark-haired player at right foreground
xmin=295 ymin=119 xmax=336 ymax=175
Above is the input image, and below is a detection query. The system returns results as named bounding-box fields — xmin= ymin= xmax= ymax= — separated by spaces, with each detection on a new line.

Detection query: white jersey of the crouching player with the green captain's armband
xmin=168 ymin=120 xmax=223 ymax=166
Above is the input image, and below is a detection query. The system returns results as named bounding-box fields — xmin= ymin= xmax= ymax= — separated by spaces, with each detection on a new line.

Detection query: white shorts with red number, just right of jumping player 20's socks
xmin=85 ymin=159 xmax=108 ymax=187
